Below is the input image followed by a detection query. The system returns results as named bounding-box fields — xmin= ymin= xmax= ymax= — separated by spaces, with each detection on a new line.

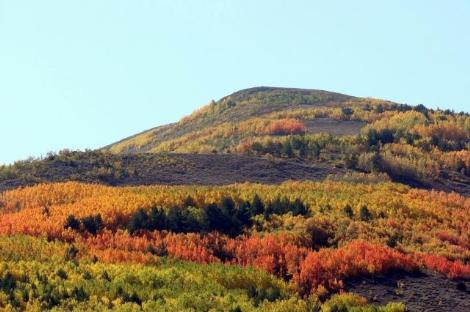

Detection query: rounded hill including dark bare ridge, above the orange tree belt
xmin=0 ymin=87 xmax=470 ymax=194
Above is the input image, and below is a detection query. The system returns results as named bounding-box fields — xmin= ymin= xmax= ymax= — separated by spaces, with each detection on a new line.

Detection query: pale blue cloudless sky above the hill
xmin=0 ymin=0 xmax=470 ymax=164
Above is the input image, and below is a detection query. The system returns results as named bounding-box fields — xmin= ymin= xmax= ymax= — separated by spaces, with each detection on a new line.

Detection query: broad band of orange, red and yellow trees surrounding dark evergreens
xmin=0 ymin=182 xmax=470 ymax=294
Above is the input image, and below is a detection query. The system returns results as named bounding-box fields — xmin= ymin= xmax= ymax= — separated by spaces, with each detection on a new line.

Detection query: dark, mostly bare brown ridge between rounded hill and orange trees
xmin=0 ymin=151 xmax=345 ymax=192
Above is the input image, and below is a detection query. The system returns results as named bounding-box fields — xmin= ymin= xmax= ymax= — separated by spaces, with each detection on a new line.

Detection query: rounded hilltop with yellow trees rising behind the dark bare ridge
xmin=103 ymin=87 xmax=470 ymax=194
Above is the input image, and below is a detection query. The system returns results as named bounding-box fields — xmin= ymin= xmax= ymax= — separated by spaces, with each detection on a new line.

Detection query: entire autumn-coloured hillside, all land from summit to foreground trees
xmin=0 ymin=87 xmax=470 ymax=312
